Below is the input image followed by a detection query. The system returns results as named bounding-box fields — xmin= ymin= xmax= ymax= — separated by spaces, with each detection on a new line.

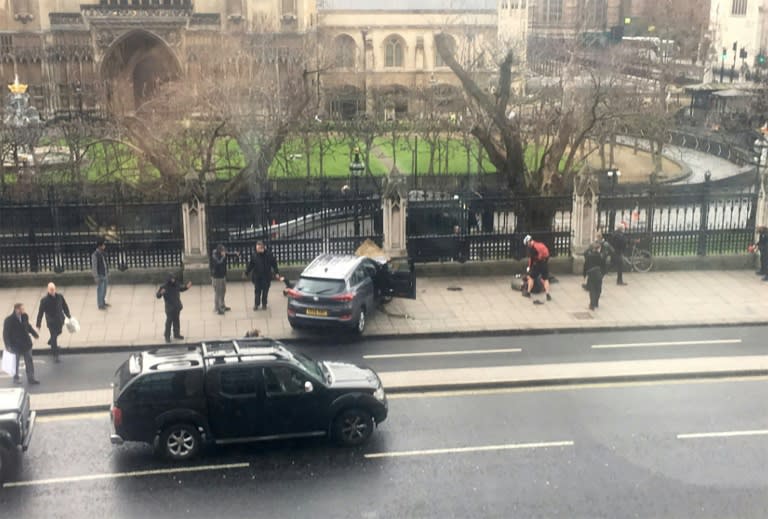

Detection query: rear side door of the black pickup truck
xmin=207 ymin=365 xmax=265 ymax=441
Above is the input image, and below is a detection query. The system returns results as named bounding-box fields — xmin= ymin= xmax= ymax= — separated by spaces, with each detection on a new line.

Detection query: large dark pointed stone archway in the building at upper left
xmin=101 ymin=30 xmax=182 ymax=113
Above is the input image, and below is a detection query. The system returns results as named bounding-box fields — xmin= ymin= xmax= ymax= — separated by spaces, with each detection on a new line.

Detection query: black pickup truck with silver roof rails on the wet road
xmin=111 ymin=338 xmax=387 ymax=460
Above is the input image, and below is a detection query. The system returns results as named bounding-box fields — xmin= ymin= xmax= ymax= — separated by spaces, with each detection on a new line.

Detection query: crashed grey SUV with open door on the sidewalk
xmin=286 ymin=254 xmax=416 ymax=334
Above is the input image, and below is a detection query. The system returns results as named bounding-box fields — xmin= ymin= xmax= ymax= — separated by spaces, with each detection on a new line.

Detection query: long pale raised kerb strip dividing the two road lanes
xmin=31 ymin=355 xmax=768 ymax=415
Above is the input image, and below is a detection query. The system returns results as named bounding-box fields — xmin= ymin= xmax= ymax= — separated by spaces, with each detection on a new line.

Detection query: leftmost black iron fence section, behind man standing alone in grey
xmin=0 ymin=198 xmax=184 ymax=273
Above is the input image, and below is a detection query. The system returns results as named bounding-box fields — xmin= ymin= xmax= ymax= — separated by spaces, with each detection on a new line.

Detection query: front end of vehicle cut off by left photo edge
xmin=0 ymin=388 xmax=35 ymax=483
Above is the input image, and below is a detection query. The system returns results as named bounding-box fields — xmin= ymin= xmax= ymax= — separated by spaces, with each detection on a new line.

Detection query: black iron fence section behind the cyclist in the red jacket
xmin=407 ymin=193 xmax=572 ymax=262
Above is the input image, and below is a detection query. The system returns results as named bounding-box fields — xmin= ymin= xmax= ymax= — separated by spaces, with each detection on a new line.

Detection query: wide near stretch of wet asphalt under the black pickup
xmin=0 ymin=378 xmax=768 ymax=519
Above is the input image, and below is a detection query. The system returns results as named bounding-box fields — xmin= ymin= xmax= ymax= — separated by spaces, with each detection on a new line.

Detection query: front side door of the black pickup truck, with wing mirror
xmin=262 ymin=365 xmax=327 ymax=436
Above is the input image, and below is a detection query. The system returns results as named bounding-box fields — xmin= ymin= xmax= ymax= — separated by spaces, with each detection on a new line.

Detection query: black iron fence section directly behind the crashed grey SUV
xmin=207 ymin=192 xmax=383 ymax=267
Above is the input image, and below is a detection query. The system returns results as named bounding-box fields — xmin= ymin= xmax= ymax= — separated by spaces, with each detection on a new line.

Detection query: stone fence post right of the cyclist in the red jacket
xmin=571 ymin=174 xmax=600 ymax=274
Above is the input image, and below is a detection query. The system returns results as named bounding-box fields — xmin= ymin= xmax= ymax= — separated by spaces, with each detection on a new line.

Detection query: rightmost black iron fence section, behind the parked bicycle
xmin=599 ymin=184 xmax=757 ymax=256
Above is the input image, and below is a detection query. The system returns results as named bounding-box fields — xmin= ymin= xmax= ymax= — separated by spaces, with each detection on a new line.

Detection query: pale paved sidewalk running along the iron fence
xmin=0 ymin=271 xmax=768 ymax=350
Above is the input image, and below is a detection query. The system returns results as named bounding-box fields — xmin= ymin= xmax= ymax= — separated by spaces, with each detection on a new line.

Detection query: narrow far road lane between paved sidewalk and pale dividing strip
xmin=0 ymin=326 xmax=768 ymax=393
